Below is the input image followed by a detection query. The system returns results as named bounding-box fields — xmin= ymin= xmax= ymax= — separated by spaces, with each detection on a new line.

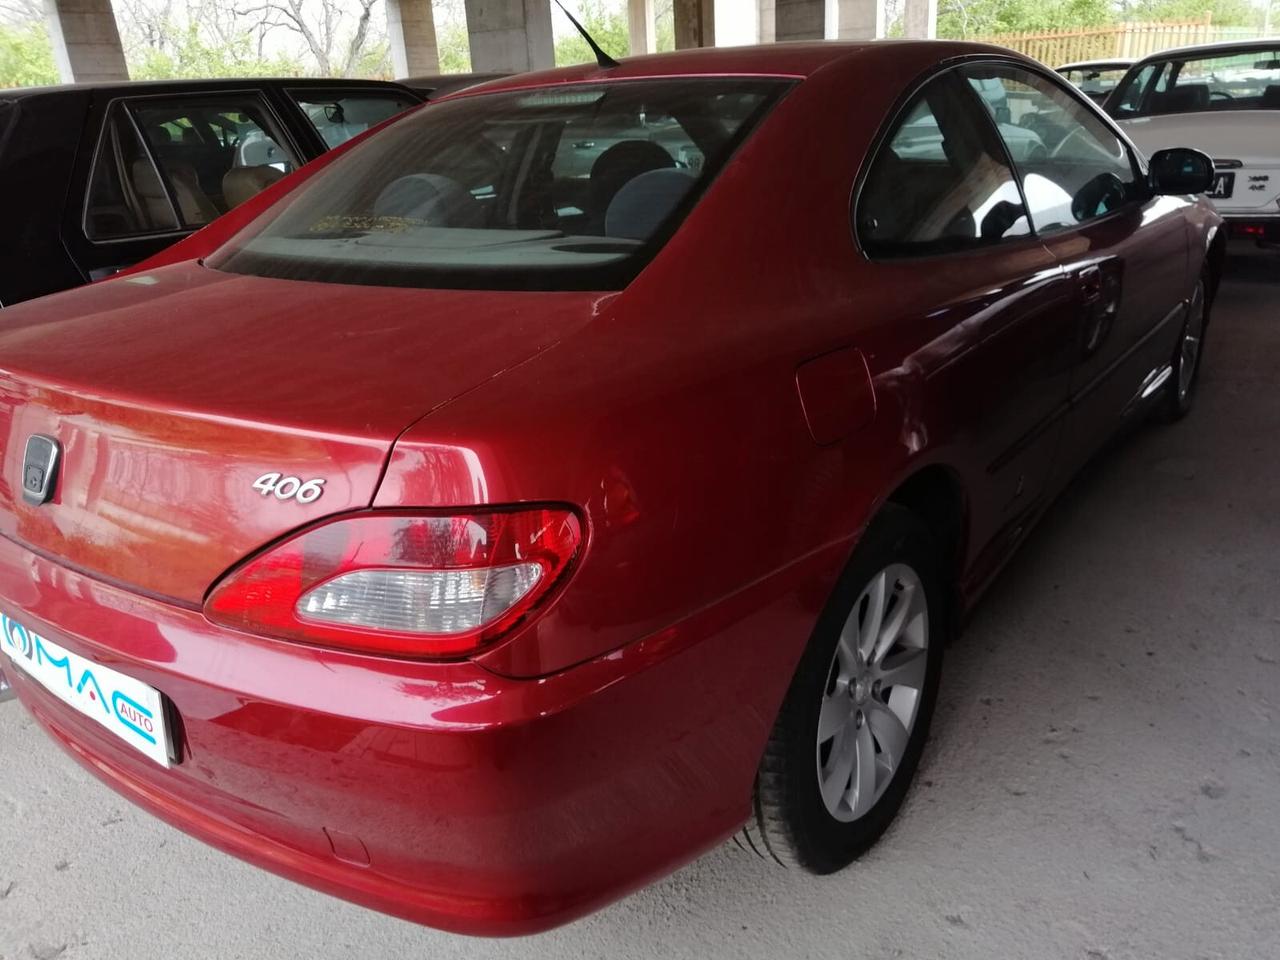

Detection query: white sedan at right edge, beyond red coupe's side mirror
xmin=1106 ymin=38 xmax=1280 ymax=242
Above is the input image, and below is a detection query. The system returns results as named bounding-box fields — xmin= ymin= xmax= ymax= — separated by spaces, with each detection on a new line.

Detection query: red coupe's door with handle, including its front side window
xmin=963 ymin=63 xmax=1193 ymax=480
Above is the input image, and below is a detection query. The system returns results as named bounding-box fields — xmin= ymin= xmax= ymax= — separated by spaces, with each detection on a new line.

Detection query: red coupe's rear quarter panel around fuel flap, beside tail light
xmin=375 ymin=54 xmax=1049 ymax=686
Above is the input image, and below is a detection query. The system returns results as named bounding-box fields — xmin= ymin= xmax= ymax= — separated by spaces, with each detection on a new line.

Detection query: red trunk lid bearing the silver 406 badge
xmin=0 ymin=262 xmax=599 ymax=604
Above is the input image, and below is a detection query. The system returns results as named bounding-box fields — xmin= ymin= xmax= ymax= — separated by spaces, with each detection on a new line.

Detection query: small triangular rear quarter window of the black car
xmin=84 ymin=104 xmax=180 ymax=241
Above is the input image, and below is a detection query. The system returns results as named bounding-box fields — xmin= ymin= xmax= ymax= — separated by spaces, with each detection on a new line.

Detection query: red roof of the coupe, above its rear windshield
xmin=449 ymin=40 xmax=1033 ymax=99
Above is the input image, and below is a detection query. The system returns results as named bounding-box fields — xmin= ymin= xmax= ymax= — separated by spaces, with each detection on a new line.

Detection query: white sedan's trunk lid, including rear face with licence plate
xmin=1120 ymin=110 xmax=1280 ymax=216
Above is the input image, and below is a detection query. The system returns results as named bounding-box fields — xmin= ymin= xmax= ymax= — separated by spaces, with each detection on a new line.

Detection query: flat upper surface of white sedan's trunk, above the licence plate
xmin=1120 ymin=110 xmax=1280 ymax=168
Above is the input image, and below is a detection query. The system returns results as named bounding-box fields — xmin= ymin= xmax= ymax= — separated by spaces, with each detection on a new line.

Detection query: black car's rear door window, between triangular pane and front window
xmin=129 ymin=93 xmax=298 ymax=228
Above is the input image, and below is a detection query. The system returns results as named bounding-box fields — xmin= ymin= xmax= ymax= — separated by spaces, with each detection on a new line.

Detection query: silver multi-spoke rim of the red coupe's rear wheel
xmin=817 ymin=563 xmax=929 ymax=823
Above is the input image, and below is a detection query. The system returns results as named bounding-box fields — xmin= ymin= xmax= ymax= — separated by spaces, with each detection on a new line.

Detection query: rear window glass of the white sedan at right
xmin=1108 ymin=44 xmax=1280 ymax=118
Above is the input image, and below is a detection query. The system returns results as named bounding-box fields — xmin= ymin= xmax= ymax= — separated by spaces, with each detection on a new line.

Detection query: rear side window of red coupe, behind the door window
xmin=855 ymin=74 xmax=1030 ymax=257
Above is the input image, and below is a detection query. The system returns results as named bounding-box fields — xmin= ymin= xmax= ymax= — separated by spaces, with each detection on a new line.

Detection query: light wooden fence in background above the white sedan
xmin=974 ymin=13 xmax=1261 ymax=67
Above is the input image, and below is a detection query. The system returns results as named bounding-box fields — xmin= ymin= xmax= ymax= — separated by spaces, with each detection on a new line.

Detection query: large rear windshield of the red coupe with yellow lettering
xmin=209 ymin=78 xmax=787 ymax=289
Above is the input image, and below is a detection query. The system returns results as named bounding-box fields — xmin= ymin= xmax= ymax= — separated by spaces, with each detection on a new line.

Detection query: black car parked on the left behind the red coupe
xmin=0 ymin=79 xmax=422 ymax=306
